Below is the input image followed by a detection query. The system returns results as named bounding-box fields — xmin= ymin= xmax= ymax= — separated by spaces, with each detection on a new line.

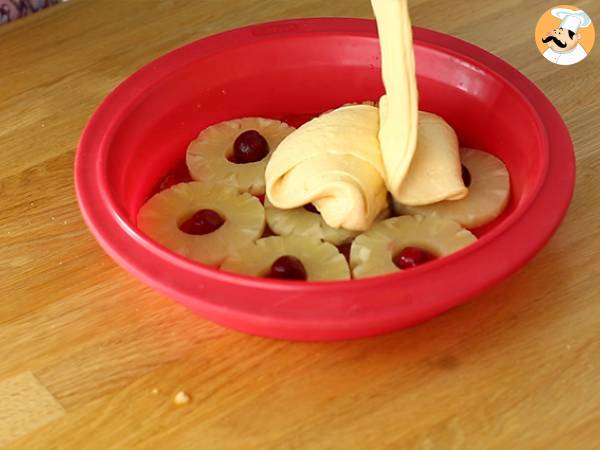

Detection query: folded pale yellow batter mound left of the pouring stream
xmin=265 ymin=105 xmax=387 ymax=231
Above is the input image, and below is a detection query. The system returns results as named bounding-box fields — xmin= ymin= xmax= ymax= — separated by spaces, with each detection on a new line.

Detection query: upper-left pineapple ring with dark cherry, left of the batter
xmin=186 ymin=117 xmax=294 ymax=195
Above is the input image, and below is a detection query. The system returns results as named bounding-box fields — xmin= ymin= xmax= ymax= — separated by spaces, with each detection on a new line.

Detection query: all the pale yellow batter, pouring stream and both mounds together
xmin=265 ymin=0 xmax=468 ymax=231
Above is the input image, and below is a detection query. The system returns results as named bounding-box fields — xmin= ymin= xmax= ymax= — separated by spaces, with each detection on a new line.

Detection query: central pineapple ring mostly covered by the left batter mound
xmin=265 ymin=198 xmax=359 ymax=245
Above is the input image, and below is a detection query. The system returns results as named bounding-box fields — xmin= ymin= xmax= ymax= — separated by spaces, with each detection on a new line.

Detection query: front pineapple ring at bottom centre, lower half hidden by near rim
xmin=221 ymin=236 xmax=350 ymax=281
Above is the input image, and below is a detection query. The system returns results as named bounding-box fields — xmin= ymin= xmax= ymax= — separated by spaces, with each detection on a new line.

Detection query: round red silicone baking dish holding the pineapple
xmin=75 ymin=18 xmax=575 ymax=340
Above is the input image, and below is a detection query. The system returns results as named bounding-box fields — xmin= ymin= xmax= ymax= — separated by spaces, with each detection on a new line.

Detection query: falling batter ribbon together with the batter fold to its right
xmin=371 ymin=0 xmax=468 ymax=205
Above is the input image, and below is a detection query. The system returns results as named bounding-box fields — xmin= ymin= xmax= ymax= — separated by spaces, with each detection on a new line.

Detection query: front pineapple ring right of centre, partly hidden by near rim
xmin=350 ymin=216 xmax=477 ymax=278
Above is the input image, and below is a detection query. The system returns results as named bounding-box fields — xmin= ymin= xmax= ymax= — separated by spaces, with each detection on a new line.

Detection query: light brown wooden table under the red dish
xmin=0 ymin=0 xmax=600 ymax=450
